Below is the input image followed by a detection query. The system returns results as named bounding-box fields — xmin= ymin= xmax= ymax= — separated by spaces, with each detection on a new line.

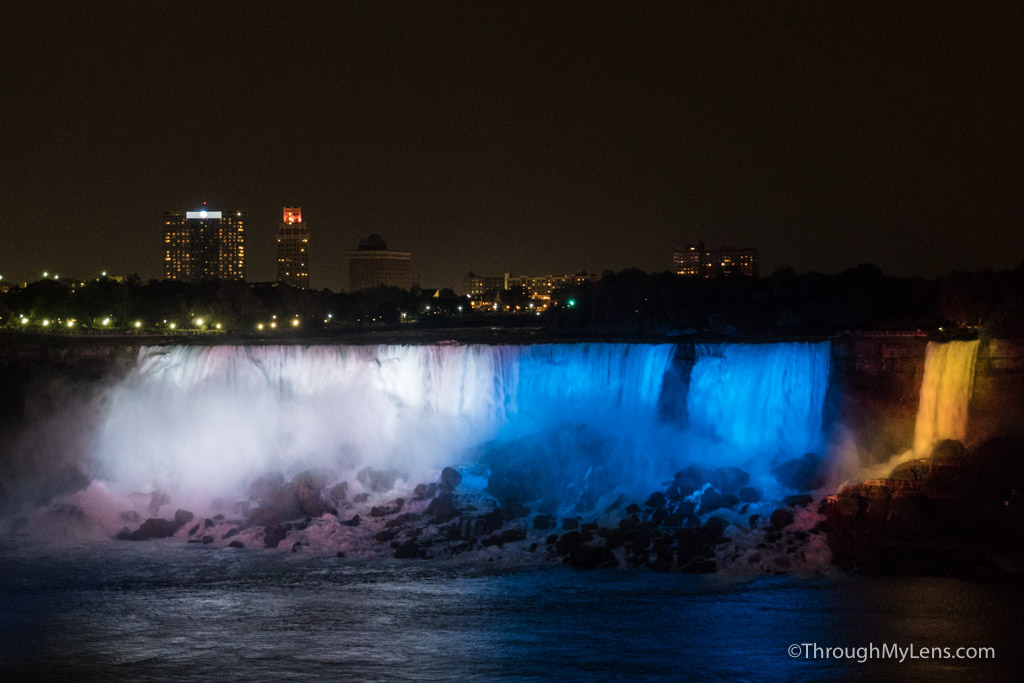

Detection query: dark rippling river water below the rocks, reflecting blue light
xmin=0 ymin=543 xmax=1024 ymax=681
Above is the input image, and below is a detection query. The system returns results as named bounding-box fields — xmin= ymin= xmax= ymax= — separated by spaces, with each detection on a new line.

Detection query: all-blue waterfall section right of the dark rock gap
xmin=686 ymin=342 xmax=830 ymax=458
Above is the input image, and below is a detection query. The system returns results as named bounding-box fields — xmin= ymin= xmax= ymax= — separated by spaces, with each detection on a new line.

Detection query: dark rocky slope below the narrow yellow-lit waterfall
xmin=825 ymin=439 xmax=1024 ymax=575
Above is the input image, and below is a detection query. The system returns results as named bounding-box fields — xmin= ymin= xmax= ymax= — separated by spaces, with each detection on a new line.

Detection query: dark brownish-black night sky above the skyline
xmin=0 ymin=0 xmax=1024 ymax=289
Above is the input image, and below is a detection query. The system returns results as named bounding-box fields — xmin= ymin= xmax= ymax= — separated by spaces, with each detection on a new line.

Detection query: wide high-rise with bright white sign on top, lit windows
xmin=164 ymin=206 xmax=246 ymax=283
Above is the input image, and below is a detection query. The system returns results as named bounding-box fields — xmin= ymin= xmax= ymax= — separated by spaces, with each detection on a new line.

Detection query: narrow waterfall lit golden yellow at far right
xmin=913 ymin=340 xmax=978 ymax=457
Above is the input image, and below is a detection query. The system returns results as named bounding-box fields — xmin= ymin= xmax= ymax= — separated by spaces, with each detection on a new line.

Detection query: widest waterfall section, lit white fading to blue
xmin=96 ymin=343 xmax=675 ymax=494
